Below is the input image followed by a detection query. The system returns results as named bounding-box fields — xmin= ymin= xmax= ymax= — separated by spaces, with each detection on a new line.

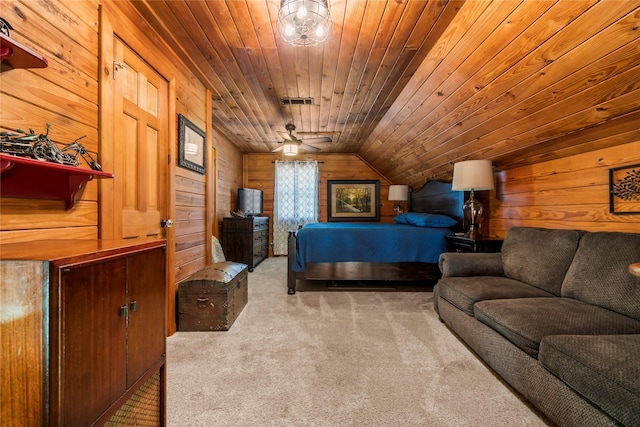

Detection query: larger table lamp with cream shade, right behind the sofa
xmin=451 ymin=160 xmax=493 ymax=238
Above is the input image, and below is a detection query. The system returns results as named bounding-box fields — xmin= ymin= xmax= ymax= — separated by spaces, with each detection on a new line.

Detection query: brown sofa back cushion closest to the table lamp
xmin=502 ymin=227 xmax=584 ymax=296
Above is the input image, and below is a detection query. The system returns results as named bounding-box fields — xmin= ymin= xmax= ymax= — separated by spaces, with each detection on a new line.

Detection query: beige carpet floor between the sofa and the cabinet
xmin=167 ymin=257 xmax=548 ymax=427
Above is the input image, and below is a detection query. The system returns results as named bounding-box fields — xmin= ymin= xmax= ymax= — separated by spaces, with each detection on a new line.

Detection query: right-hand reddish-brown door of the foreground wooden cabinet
xmin=127 ymin=248 xmax=167 ymax=387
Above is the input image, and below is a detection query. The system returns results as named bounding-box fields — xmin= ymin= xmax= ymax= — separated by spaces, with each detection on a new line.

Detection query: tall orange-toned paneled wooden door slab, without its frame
xmin=113 ymin=38 xmax=169 ymax=239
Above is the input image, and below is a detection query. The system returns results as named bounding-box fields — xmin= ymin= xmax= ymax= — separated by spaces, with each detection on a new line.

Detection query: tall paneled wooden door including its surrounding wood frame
xmin=98 ymin=21 xmax=177 ymax=334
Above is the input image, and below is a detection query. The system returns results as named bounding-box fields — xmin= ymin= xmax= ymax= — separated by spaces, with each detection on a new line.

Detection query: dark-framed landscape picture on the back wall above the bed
xmin=327 ymin=180 xmax=380 ymax=221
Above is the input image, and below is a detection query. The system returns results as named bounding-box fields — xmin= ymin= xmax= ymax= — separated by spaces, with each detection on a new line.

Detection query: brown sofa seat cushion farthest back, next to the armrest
xmin=438 ymin=276 xmax=553 ymax=316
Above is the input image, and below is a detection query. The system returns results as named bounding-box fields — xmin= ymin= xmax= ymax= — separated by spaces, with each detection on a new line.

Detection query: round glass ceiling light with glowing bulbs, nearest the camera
xmin=278 ymin=0 xmax=331 ymax=46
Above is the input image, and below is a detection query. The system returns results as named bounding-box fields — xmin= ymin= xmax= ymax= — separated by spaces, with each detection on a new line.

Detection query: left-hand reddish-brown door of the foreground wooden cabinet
xmin=60 ymin=259 xmax=126 ymax=426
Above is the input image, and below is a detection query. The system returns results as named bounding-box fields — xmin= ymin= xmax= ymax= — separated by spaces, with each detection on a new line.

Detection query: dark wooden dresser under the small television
xmin=222 ymin=216 xmax=269 ymax=271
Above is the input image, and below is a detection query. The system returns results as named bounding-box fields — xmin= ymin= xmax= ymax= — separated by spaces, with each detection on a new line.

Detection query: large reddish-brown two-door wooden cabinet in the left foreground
xmin=0 ymin=240 xmax=166 ymax=426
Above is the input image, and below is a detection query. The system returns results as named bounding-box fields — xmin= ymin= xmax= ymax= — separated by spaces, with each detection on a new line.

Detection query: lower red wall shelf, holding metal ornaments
xmin=0 ymin=153 xmax=113 ymax=210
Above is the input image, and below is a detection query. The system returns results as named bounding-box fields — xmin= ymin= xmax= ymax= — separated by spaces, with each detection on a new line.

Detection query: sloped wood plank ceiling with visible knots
xmin=133 ymin=0 xmax=640 ymax=186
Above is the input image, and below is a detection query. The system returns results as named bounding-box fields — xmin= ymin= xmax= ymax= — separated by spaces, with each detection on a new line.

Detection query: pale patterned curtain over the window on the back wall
xmin=273 ymin=161 xmax=318 ymax=255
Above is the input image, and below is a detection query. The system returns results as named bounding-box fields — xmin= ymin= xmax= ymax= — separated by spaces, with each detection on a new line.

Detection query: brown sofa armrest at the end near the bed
xmin=438 ymin=252 xmax=504 ymax=277
